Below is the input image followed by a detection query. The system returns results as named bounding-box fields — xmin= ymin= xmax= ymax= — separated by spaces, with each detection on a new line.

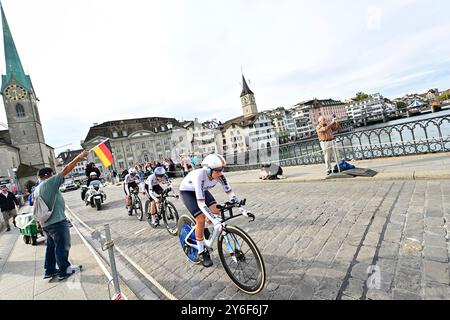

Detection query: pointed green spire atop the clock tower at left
xmin=0 ymin=2 xmax=32 ymax=92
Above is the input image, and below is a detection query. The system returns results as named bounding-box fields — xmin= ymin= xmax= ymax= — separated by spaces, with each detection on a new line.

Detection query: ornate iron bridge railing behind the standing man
xmin=227 ymin=115 xmax=450 ymax=170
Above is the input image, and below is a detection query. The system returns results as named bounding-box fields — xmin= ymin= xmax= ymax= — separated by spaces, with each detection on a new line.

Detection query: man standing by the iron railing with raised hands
xmin=316 ymin=115 xmax=339 ymax=175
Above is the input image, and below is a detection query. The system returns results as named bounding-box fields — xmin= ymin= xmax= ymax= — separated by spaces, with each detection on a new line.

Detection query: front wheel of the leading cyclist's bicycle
xmin=217 ymin=226 xmax=266 ymax=295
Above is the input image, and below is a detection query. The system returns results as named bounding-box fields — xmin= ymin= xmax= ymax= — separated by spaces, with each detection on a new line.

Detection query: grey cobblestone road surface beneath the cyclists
xmin=65 ymin=181 xmax=450 ymax=300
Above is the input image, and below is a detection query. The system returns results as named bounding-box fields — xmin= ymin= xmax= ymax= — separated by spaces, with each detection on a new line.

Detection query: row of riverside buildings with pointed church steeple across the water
xmin=81 ymin=76 xmax=404 ymax=172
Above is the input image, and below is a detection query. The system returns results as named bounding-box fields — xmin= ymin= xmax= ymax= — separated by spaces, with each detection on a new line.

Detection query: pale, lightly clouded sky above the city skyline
xmin=0 ymin=0 xmax=450 ymax=152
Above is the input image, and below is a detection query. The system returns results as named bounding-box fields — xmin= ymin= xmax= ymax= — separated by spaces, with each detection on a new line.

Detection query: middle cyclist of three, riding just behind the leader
xmin=145 ymin=167 xmax=173 ymax=227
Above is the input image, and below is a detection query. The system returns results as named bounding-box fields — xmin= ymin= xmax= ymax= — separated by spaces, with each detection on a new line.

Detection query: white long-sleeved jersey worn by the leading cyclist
xmin=180 ymin=168 xmax=232 ymax=200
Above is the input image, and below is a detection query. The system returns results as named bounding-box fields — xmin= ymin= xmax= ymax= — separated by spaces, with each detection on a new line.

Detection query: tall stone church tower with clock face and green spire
xmin=0 ymin=2 xmax=53 ymax=168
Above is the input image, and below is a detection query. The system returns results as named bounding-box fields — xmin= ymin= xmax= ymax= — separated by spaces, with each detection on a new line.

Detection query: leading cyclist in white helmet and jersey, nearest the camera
xmin=180 ymin=154 xmax=239 ymax=267
